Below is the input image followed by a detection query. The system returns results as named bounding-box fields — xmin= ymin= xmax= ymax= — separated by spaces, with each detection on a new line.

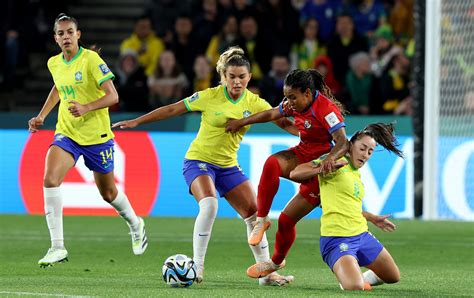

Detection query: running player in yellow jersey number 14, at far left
xmin=28 ymin=13 xmax=148 ymax=267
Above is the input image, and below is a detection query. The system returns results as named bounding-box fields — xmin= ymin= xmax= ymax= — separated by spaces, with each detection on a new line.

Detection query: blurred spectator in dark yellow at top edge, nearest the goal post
xmin=388 ymin=0 xmax=415 ymax=46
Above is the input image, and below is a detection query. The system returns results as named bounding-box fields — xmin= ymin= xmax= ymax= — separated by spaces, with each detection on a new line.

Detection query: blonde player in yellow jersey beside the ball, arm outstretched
xmin=112 ymin=47 xmax=297 ymax=285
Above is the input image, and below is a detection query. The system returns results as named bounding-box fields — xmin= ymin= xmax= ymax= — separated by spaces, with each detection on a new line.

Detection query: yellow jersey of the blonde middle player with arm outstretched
xmin=184 ymin=85 xmax=272 ymax=167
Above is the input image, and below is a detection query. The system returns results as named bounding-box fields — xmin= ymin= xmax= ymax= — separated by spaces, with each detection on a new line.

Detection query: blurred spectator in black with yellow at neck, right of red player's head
xmin=328 ymin=14 xmax=368 ymax=85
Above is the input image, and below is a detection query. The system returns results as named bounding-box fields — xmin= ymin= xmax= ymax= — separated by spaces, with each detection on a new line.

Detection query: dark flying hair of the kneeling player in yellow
xmin=350 ymin=123 xmax=404 ymax=158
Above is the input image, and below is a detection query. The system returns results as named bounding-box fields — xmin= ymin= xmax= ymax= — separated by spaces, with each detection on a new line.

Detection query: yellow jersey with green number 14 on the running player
xmin=48 ymin=47 xmax=115 ymax=145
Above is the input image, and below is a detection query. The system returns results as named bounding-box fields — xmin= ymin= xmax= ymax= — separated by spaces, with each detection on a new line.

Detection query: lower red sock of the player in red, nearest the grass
xmin=272 ymin=213 xmax=296 ymax=264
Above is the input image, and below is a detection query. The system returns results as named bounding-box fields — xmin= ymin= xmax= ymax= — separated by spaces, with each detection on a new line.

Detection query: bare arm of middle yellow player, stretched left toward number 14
xmin=112 ymin=100 xmax=188 ymax=129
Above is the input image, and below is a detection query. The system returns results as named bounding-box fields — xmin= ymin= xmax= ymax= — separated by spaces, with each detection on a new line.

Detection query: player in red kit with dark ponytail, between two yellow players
xmin=226 ymin=69 xmax=350 ymax=270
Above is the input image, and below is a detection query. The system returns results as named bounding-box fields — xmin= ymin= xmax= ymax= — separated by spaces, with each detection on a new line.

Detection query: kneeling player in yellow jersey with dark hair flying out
xmin=291 ymin=123 xmax=403 ymax=290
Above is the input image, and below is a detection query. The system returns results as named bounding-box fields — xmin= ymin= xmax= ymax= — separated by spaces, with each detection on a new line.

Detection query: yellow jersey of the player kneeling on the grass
xmin=313 ymin=157 xmax=368 ymax=237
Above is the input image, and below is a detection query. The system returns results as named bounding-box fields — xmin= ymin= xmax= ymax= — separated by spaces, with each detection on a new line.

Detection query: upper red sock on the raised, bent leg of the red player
xmin=257 ymin=155 xmax=281 ymax=217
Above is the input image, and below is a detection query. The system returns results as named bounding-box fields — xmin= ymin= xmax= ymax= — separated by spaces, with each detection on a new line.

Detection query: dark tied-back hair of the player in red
xmin=285 ymin=69 xmax=346 ymax=115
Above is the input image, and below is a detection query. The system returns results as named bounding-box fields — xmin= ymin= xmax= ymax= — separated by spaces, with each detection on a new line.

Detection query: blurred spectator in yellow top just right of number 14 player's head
xmin=120 ymin=16 xmax=165 ymax=76
